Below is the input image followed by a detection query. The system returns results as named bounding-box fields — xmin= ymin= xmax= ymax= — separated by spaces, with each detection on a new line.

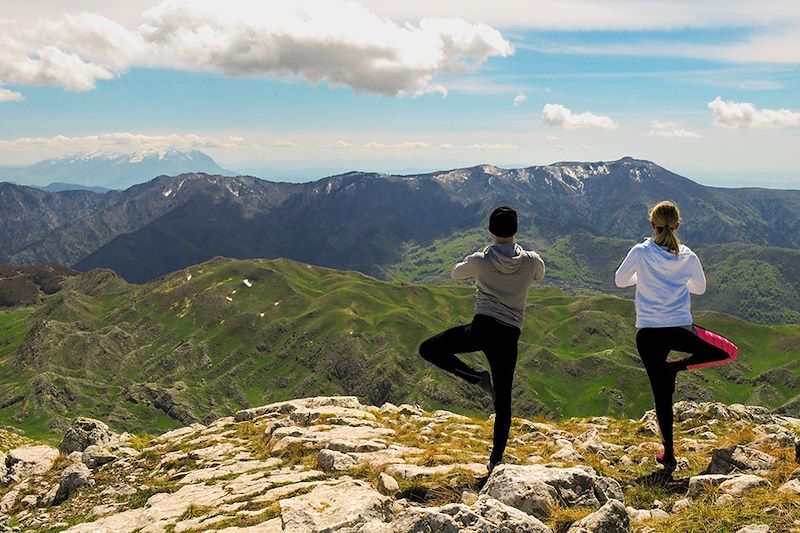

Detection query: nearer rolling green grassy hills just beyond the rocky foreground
xmin=0 ymin=258 xmax=800 ymax=437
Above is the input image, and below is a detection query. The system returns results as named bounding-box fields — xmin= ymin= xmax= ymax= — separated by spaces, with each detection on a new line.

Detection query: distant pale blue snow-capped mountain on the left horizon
xmin=0 ymin=150 xmax=233 ymax=189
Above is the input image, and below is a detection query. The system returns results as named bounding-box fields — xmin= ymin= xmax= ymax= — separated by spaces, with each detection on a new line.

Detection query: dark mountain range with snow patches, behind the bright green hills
xmin=0 ymin=158 xmax=800 ymax=323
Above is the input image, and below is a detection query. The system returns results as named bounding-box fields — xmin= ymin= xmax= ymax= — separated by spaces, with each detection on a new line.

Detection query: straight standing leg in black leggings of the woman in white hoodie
xmin=636 ymin=328 xmax=675 ymax=460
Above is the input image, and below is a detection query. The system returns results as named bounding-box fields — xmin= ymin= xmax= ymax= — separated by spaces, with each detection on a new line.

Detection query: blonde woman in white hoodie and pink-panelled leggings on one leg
xmin=615 ymin=201 xmax=739 ymax=471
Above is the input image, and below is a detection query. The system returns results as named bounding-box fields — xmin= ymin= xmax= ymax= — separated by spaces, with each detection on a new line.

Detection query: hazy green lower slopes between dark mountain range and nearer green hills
xmin=386 ymin=229 xmax=800 ymax=324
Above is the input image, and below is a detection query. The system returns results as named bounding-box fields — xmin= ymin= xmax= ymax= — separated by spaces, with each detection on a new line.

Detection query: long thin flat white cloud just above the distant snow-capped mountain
xmin=0 ymin=132 xmax=246 ymax=153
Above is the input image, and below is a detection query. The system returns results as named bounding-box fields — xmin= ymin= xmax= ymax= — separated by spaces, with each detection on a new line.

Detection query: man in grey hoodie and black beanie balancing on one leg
xmin=419 ymin=206 xmax=544 ymax=474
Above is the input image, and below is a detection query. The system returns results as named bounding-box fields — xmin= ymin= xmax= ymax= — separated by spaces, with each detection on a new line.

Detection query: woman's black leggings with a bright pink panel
xmin=636 ymin=326 xmax=739 ymax=456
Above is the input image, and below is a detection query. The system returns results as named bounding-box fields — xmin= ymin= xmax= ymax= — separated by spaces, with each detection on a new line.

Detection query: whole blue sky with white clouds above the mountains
xmin=0 ymin=0 xmax=800 ymax=189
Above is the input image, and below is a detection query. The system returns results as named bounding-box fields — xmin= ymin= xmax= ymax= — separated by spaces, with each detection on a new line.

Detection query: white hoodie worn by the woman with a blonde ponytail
xmin=614 ymin=238 xmax=706 ymax=328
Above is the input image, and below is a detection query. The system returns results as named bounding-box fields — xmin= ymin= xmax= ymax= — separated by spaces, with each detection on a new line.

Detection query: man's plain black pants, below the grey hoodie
xmin=419 ymin=315 xmax=520 ymax=462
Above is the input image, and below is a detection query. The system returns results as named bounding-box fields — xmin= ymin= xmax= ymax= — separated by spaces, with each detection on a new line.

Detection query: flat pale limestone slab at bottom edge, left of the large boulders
xmin=280 ymin=478 xmax=392 ymax=531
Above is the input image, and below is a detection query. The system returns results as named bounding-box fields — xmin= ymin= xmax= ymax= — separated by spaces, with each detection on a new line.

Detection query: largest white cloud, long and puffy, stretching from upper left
xmin=0 ymin=0 xmax=514 ymax=96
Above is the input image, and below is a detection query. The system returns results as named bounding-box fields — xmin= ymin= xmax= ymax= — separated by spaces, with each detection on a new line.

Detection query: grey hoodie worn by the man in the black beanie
xmin=453 ymin=242 xmax=544 ymax=329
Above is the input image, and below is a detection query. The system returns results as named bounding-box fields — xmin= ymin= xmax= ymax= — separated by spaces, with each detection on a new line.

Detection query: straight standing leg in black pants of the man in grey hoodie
xmin=484 ymin=326 xmax=519 ymax=464
